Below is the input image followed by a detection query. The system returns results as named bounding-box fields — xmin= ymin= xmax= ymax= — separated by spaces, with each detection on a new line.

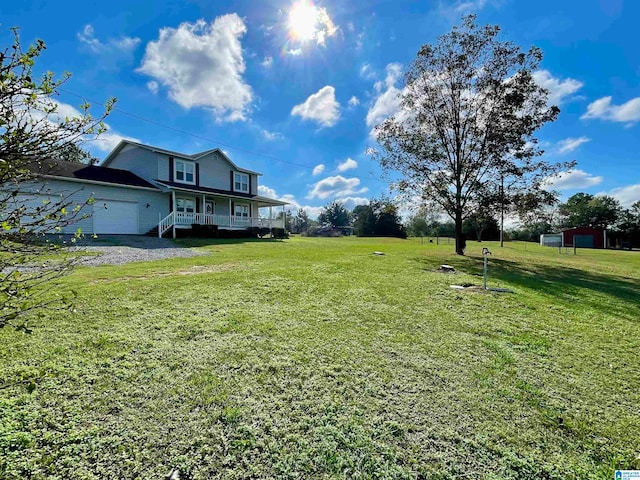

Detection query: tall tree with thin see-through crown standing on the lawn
xmin=372 ymin=16 xmax=567 ymax=255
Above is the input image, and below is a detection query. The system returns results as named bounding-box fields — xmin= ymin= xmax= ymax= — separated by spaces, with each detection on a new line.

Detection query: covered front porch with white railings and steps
xmin=158 ymin=187 xmax=287 ymax=238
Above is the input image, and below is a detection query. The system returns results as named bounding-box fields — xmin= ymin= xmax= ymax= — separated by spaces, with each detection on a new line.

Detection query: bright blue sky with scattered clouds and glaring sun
xmin=0 ymin=0 xmax=640 ymax=216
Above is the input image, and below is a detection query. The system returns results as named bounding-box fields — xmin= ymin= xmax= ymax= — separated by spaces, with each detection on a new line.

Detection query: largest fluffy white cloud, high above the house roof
xmin=138 ymin=13 xmax=253 ymax=121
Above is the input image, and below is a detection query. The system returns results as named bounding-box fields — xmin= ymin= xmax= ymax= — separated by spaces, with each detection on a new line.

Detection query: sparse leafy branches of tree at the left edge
xmin=0 ymin=29 xmax=115 ymax=330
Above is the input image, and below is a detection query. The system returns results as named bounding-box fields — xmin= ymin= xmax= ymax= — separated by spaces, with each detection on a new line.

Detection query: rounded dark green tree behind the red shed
xmin=558 ymin=193 xmax=622 ymax=229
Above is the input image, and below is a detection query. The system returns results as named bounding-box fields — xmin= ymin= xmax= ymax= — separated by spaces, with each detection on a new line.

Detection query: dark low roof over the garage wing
xmin=28 ymin=159 xmax=157 ymax=190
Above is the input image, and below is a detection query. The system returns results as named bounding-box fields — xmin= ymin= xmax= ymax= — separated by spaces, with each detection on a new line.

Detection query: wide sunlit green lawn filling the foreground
xmin=0 ymin=238 xmax=640 ymax=479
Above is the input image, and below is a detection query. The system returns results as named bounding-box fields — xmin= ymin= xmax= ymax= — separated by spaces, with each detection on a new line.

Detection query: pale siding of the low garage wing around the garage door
xmin=21 ymin=179 xmax=169 ymax=234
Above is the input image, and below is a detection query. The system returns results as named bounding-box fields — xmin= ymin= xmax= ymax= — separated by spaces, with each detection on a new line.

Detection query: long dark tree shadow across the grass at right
xmin=420 ymin=256 xmax=640 ymax=321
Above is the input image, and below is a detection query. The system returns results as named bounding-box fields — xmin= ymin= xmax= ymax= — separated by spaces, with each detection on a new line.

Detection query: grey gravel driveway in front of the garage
xmin=71 ymin=235 xmax=205 ymax=265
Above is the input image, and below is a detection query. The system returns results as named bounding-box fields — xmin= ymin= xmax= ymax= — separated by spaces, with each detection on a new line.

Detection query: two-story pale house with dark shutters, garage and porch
xmin=22 ymin=140 xmax=286 ymax=238
